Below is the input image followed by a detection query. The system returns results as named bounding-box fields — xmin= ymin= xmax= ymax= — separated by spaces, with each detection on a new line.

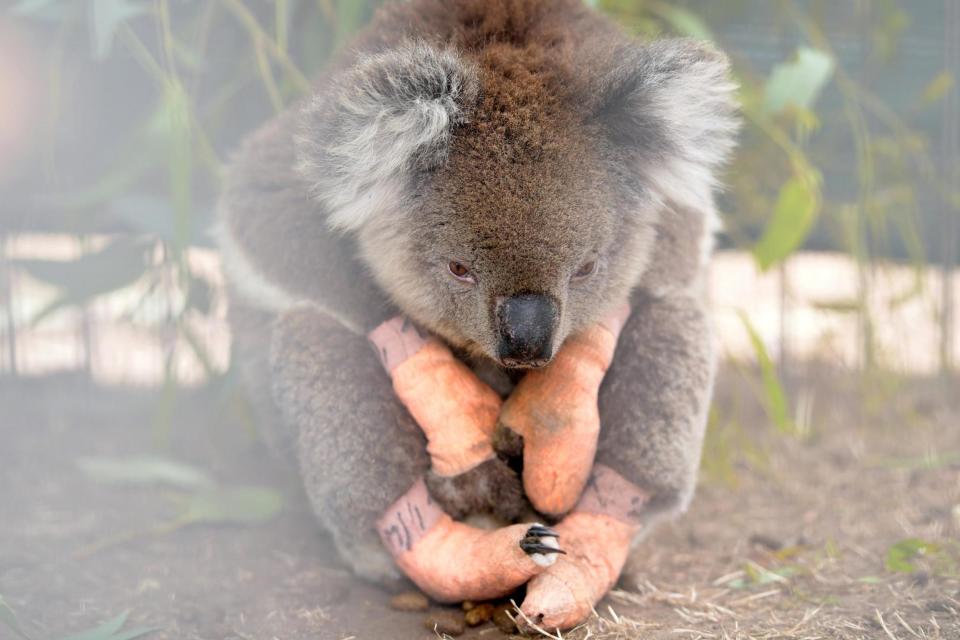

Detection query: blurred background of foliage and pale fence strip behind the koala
xmin=0 ymin=0 xmax=960 ymax=637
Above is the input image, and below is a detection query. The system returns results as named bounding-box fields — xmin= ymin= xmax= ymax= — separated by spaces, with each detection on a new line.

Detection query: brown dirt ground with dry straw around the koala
xmin=0 ymin=368 xmax=960 ymax=640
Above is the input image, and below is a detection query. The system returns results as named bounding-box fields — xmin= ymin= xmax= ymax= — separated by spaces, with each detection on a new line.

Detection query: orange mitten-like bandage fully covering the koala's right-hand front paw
xmin=500 ymin=305 xmax=630 ymax=516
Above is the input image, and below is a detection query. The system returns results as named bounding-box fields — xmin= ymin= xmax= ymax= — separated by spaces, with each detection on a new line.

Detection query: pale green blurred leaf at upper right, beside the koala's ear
xmin=763 ymin=47 xmax=834 ymax=114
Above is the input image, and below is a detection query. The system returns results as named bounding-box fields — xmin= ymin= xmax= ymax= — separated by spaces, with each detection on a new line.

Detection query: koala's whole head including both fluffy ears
xmin=298 ymin=41 xmax=736 ymax=367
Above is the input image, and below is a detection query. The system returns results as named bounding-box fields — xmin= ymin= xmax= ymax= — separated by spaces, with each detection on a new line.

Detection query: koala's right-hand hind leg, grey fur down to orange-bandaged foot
xmin=522 ymin=296 xmax=714 ymax=628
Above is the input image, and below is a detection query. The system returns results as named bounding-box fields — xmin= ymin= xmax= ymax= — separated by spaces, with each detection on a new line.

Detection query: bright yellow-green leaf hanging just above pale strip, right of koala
xmin=753 ymin=175 xmax=820 ymax=271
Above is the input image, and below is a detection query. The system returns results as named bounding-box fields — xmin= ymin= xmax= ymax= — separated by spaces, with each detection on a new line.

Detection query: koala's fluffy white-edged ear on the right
xmin=596 ymin=40 xmax=740 ymax=212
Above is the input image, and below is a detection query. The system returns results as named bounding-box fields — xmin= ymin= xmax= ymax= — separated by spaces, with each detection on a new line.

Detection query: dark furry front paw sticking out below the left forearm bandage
xmin=426 ymin=458 xmax=529 ymax=522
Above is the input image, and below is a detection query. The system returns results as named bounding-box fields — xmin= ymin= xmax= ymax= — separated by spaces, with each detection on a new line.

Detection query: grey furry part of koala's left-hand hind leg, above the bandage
xmin=270 ymin=309 xmax=429 ymax=584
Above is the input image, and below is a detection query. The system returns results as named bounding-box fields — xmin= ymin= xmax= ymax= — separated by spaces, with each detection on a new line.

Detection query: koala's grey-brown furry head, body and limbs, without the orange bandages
xmin=218 ymin=0 xmax=738 ymax=584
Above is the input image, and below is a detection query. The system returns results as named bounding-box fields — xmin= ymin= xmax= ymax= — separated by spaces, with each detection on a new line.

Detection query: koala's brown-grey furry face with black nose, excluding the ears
xmin=360 ymin=116 xmax=652 ymax=368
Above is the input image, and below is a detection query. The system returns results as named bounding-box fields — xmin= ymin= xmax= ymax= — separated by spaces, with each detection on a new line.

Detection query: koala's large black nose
xmin=497 ymin=293 xmax=559 ymax=367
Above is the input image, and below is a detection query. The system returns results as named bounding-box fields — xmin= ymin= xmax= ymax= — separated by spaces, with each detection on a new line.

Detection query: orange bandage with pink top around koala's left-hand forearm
xmin=369 ymin=317 xmax=502 ymax=477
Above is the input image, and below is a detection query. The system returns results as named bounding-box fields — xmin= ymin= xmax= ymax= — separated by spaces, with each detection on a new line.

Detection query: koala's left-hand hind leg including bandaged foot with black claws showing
xmin=270 ymin=309 xmax=563 ymax=601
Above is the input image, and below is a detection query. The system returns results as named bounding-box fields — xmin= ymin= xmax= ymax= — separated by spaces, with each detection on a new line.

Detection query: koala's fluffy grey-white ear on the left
xmin=296 ymin=41 xmax=479 ymax=230
